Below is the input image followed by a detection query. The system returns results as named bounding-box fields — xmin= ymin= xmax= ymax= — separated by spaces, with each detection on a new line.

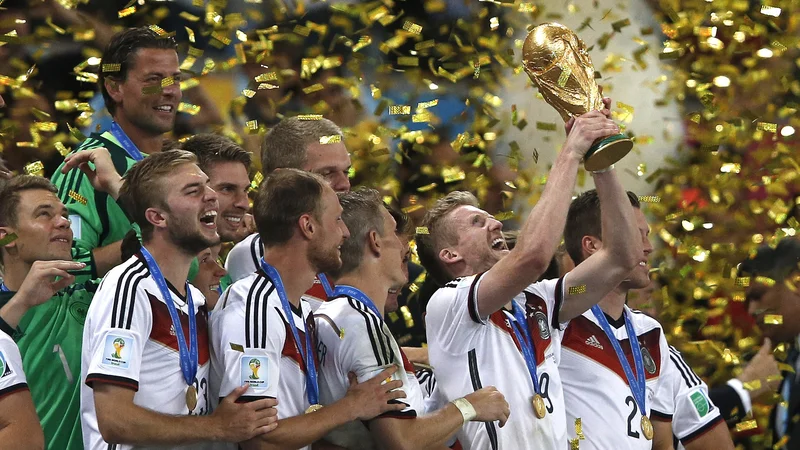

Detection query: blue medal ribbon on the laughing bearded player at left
xmin=142 ymin=246 xmax=197 ymax=386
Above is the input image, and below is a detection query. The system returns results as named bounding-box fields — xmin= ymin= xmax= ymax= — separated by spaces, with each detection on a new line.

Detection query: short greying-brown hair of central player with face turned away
xmin=331 ymin=188 xmax=385 ymax=278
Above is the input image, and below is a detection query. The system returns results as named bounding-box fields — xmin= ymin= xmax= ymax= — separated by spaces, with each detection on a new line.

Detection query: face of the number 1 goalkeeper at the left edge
xmin=2 ymin=189 xmax=72 ymax=264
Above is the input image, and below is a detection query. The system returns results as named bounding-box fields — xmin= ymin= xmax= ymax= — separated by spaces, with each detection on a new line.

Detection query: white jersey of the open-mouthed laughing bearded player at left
xmin=81 ymin=253 xmax=210 ymax=450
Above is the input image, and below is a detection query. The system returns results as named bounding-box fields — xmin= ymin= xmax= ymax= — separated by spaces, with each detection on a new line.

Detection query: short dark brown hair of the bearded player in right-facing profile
xmin=253 ymin=169 xmax=327 ymax=248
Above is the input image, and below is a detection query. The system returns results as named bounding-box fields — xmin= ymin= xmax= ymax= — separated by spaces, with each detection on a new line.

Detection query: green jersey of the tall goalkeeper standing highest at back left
xmin=52 ymin=132 xmax=136 ymax=284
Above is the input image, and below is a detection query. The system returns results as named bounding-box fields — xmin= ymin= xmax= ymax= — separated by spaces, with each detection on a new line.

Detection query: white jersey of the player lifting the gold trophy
xmin=425 ymin=274 xmax=567 ymax=450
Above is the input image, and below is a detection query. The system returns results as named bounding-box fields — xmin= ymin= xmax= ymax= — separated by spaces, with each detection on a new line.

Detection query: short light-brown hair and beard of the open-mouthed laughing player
xmin=119 ymin=150 xmax=197 ymax=242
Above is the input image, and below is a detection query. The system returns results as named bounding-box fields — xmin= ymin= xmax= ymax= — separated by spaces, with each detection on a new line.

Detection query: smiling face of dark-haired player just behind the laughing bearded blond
xmin=203 ymin=161 xmax=250 ymax=242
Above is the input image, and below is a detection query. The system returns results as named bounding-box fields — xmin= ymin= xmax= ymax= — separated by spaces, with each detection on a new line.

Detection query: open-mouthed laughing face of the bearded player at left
xmin=156 ymin=164 xmax=220 ymax=255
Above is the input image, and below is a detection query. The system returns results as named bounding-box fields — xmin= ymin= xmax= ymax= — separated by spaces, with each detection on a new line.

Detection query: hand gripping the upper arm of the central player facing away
xmin=340 ymin=366 xmax=408 ymax=420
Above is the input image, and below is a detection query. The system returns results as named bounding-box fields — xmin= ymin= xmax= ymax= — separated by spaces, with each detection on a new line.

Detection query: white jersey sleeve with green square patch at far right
xmin=652 ymin=346 xmax=723 ymax=446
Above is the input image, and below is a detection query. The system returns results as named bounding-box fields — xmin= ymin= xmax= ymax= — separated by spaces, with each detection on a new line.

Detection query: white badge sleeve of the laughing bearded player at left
xmin=83 ymin=278 xmax=153 ymax=390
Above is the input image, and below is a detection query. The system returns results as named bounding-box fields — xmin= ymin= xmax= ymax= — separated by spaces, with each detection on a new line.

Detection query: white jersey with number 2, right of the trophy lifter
xmin=559 ymin=306 xmax=669 ymax=450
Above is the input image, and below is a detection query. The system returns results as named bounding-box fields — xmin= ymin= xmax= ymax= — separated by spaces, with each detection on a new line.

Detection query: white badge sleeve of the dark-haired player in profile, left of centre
xmin=213 ymin=285 xmax=286 ymax=402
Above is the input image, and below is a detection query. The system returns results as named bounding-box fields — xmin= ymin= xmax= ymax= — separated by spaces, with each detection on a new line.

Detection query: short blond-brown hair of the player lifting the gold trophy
xmin=416 ymin=191 xmax=478 ymax=284
